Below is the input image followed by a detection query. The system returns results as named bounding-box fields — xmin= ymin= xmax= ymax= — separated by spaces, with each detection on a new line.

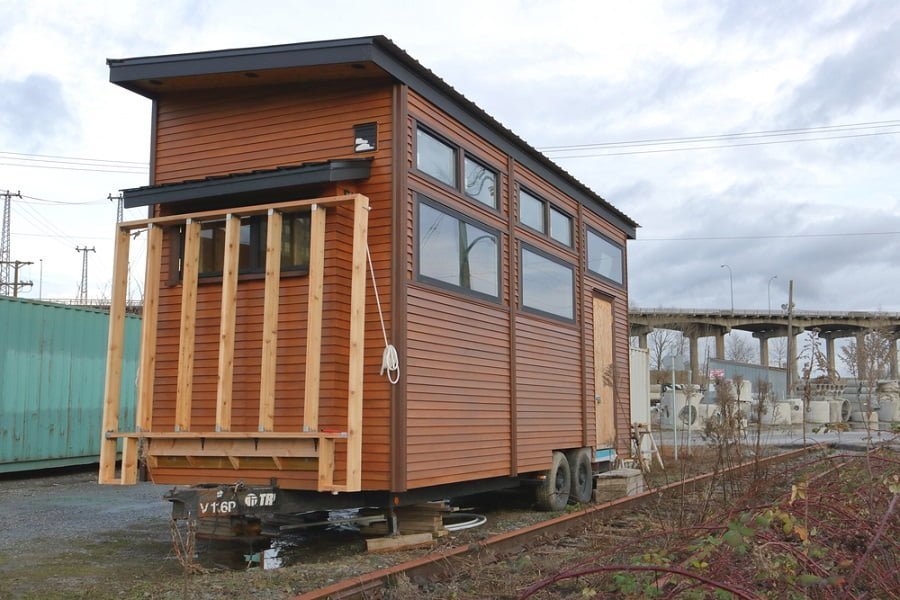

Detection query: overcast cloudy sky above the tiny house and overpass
xmin=0 ymin=0 xmax=900 ymax=311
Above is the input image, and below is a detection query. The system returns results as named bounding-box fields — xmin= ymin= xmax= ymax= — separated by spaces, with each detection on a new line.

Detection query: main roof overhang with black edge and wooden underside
xmin=106 ymin=36 xmax=638 ymax=234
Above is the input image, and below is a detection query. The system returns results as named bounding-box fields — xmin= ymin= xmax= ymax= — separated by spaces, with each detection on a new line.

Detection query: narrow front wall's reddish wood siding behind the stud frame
xmin=152 ymin=82 xmax=394 ymax=489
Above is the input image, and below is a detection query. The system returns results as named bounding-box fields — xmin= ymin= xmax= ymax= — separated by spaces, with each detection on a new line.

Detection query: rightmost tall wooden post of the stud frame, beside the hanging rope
xmin=347 ymin=194 xmax=369 ymax=492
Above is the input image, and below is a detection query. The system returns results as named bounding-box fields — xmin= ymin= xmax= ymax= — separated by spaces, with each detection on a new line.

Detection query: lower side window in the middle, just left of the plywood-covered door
xmin=520 ymin=246 xmax=575 ymax=320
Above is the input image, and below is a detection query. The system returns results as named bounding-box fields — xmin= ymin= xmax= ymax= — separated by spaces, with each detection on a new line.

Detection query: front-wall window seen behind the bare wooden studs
xmin=179 ymin=212 xmax=310 ymax=277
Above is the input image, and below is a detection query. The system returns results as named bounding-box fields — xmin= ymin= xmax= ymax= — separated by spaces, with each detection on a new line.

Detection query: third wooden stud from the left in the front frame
xmin=175 ymin=219 xmax=200 ymax=431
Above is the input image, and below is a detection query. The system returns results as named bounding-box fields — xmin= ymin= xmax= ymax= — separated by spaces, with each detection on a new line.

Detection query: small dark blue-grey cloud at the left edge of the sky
xmin=0 ymin=74 xmax=78 ymax=152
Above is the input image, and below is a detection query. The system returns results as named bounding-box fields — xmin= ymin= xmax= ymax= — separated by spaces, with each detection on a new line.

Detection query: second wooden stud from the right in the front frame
xmin=303 ymin=204 xmax=325 ymax=431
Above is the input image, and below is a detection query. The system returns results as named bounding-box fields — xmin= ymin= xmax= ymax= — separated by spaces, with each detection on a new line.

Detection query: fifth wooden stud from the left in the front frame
xmin=259 ymin=210 xmax=282 ymax=431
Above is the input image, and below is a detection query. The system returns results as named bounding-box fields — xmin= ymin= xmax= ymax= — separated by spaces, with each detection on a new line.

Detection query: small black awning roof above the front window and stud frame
xmin=122 ymin=158 xmax=372 ymax=208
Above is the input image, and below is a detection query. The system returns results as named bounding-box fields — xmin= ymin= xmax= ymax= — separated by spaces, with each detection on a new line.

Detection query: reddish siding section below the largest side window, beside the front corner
xmin=406 ymin=284 xmax=510 ymax=488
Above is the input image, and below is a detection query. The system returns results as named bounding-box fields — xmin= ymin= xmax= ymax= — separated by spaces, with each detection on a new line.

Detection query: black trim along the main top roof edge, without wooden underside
xmin=106 ymin=35 xmax=638 ymax=238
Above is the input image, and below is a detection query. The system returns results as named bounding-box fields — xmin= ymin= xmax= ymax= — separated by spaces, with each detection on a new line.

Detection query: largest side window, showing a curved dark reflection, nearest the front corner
xmin=418 ymin=198 xmax=500 ymax=299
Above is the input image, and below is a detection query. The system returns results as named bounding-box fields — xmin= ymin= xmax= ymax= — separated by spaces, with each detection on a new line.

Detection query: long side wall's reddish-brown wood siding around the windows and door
xmin=399 ymin=91 xmax=629 ymax=488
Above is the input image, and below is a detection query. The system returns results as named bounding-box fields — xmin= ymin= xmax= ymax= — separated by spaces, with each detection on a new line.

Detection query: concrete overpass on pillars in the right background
xmin=628 ymin=308 xmax=900 ymax=381
